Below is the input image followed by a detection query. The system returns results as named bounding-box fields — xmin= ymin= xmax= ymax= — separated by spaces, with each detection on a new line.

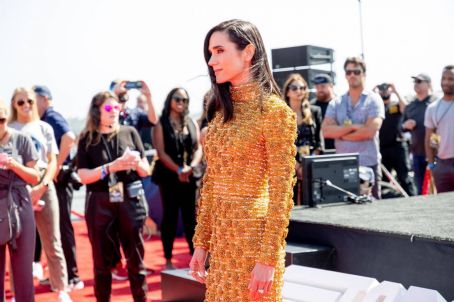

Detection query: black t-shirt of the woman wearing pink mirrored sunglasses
xmin=77 ymin=126 xmax=145 ymax=192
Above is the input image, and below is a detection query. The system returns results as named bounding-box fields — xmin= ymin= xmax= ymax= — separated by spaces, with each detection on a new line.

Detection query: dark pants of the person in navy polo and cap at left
xmin=55 ymin=183 xmax=79 ymax=283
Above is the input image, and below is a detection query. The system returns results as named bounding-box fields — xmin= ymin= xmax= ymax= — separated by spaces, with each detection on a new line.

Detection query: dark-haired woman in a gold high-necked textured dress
xmin=190 ymin=20 xmax=296 ymax=302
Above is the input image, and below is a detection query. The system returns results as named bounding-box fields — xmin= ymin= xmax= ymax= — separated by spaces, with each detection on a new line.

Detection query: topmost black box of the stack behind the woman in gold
xmin=271 ymin=45 xmax=334 ymax=69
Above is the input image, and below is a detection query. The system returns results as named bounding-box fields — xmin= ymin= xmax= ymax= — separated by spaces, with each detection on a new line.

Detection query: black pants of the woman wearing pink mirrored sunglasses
xmin=85 ymin=192 xmax=147 ymax=302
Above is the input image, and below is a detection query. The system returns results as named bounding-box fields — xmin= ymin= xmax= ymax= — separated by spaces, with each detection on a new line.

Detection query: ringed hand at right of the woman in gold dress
xmin=248 ymin=263 xmax=274 ymax=299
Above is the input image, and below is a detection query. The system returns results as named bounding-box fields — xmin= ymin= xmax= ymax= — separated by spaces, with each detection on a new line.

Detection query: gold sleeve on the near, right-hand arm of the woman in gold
xmin=258 ymin=98 xmax=297 ymax=265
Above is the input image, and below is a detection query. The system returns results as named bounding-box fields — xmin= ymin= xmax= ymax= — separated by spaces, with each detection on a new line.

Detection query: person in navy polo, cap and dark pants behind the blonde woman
xmin=33 ymin=85 xmax=84 ymax=289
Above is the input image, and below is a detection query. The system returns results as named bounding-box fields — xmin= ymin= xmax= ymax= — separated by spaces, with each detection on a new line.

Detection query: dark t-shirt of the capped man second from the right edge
xmin=403 ymin=95 xmax=432 ymax=155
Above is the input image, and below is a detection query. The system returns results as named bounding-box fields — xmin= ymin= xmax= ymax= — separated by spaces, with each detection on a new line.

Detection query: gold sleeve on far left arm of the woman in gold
xmin=192 ymin=166 xmax=213 ymax=250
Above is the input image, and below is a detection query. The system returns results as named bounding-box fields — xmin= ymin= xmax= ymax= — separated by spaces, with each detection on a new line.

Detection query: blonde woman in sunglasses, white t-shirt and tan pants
xmin=10 ymin=88 xmax=71 ymax=301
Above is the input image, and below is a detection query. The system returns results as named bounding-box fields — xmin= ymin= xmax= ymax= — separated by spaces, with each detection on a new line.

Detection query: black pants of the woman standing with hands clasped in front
xmin=159 ymin=182 xmax=196 ymax=260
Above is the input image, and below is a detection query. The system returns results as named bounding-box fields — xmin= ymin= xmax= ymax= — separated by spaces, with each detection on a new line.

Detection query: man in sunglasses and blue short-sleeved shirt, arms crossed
xmin=322 ymin=57 xmax=385 ymax=199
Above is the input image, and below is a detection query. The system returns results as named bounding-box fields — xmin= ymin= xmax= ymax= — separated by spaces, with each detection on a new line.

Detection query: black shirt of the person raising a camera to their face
xmin=380 ymin=102 xmax=403 ymax=147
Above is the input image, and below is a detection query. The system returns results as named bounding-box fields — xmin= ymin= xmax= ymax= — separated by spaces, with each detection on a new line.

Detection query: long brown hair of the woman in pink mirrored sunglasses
xmin=80 ymin=91 xmax=118 ymax=150
